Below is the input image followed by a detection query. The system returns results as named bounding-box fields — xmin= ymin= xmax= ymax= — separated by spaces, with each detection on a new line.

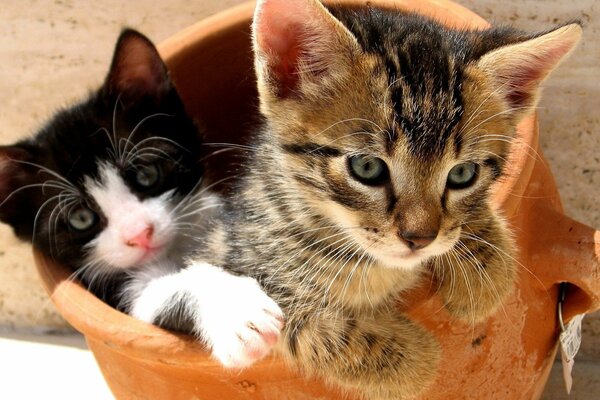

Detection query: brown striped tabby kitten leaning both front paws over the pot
xmin=190 ymin=0 xmax=581 ymax=399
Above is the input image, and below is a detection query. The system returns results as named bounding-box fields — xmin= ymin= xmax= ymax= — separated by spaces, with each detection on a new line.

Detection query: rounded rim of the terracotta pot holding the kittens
xmin=34 ymin=0 xmax=538 ymax=362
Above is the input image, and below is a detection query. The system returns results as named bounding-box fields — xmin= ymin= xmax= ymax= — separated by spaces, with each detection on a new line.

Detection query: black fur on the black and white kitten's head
xmin=0 ymin=30 xmax=203 ymax=293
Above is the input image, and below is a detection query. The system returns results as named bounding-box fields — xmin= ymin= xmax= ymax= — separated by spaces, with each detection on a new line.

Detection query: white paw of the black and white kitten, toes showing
xmin=202 ymin=275 xmax=283 ymax=368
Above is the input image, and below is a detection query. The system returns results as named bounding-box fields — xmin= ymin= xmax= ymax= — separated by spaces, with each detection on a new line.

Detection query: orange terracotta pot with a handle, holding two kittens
xmin=36 ymin=0 xmax=600 ymax=400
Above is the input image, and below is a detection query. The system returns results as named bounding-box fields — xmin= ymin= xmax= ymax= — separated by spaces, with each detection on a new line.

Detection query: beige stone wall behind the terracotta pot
xmin=0 ymin=0 xmax=600 ymax=357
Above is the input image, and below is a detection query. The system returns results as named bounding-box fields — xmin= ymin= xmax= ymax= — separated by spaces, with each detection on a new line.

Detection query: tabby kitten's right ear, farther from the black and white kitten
xmin=477 ymin=24 xmax=582 ymax=118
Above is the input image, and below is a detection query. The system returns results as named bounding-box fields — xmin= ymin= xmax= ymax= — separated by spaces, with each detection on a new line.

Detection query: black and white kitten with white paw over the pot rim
xmin=0 ymin=30 xmax=281 ymax=367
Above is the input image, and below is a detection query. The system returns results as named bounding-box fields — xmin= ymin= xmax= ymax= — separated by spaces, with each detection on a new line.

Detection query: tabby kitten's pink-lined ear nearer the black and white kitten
xmin=252 ymin=0 xmax=360 ymax=99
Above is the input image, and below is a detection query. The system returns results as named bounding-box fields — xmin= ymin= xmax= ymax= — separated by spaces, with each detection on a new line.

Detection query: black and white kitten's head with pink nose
xmin=0 ymin=30 xmax=202 ymax=272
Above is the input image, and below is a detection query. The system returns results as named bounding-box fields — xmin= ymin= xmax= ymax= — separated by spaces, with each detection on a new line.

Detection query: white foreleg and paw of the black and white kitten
xmin=126 ymin=263 xmax=283 ymax=368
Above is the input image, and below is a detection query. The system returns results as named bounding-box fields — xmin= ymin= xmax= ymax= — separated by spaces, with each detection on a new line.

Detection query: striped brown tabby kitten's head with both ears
xmin=253 ymin=0 xmax=581 ymax=268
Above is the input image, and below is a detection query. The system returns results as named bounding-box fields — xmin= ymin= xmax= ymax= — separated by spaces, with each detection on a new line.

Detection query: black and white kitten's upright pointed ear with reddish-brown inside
xmin=103 ymin=29 xmax=171 ymax=103
